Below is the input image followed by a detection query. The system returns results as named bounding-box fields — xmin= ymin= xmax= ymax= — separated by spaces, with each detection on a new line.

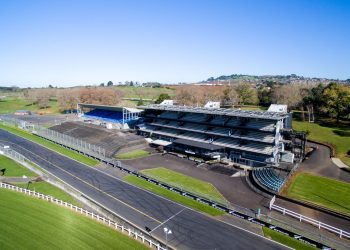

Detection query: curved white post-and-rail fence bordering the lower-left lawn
xmin=0 ymin=182 xmax=166 ymax=250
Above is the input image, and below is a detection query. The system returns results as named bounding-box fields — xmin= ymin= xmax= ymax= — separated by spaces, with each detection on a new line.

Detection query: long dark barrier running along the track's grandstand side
xmin=0 ymin=119 xmax=331 ymax=249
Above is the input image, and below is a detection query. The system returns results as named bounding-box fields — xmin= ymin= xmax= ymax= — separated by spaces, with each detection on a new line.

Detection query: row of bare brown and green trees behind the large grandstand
xmin=176 ymin=82 xmax=350 ymax=121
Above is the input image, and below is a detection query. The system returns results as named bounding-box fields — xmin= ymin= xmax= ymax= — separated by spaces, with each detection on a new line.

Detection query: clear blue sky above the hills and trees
xmin=0 ymin=0 xmax=350 ymax=87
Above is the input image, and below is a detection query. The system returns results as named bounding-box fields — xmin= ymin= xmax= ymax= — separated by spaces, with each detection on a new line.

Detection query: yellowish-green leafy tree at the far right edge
xmin=323 ymin=83 xmax=350 ymax=123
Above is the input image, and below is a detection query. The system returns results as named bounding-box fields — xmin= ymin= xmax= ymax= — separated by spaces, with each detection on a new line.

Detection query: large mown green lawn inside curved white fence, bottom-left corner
xmin=0 ymin=189 xmax=147 ymax=250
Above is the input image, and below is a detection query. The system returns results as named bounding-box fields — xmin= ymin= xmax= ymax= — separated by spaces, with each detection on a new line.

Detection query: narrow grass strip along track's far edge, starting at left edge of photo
xmin=0 ymin=124 xmax=99 ymax=166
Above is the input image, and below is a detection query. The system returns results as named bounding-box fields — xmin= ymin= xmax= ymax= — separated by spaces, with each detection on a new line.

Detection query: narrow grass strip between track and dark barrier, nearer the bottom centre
xmin=124 ymin=175 xmax=225 ymax=216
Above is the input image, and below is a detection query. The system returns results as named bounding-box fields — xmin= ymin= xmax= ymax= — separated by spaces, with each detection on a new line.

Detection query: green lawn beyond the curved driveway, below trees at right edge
xmin=293 ymin=120 xmax=350 ymax=166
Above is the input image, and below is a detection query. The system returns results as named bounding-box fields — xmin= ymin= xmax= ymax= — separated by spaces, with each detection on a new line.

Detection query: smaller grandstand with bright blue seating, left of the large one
xmin=77 ymin=103 xmax=142 ymax=129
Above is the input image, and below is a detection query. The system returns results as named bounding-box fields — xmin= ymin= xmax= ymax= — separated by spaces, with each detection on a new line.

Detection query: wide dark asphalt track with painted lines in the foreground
xmin=0 ymin=130 xmax=285 ymax=249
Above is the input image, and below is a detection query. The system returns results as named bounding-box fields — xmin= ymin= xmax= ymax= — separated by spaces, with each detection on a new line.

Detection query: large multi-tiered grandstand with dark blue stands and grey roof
xmin=136 ymin=104 xmax=294 ymax=167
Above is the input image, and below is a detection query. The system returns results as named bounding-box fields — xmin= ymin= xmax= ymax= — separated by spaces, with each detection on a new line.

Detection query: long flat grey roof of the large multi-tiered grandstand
xmin=142 ymin=104 xmax=288 ymax=120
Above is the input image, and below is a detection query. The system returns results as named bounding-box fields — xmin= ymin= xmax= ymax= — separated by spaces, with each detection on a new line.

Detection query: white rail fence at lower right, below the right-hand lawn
xmin=270 ymin=196 xmax=350 ymax=239
